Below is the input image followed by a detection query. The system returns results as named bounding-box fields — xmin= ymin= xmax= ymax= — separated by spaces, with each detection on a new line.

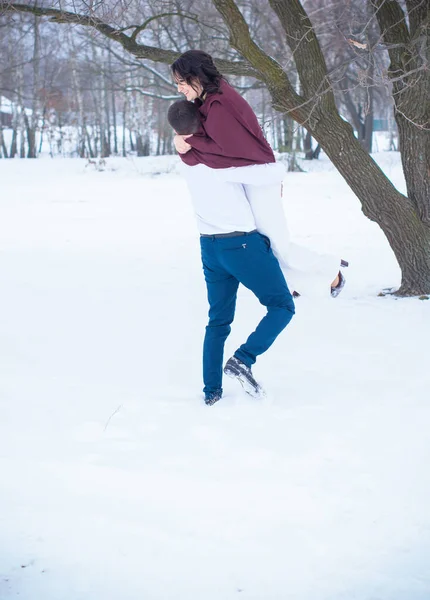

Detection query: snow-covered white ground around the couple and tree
xmin=0 ymin=153 xmax=430 ymax=600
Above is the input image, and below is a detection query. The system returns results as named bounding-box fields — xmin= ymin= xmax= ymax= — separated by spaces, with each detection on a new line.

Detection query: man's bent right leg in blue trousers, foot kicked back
xmin=220 ymin=233 xmax=294 ymax=367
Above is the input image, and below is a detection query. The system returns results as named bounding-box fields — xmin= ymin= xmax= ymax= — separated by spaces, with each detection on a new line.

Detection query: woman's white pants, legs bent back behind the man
xmin=244 ymin=184 xmax=340 ymax=296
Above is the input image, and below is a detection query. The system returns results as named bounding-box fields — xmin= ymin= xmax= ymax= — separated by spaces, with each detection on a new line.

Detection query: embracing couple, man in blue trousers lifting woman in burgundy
xmin=168 ymin=50 xmax=345 ymax=406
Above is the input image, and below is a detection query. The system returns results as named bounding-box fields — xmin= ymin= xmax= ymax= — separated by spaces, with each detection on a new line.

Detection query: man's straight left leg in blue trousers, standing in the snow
xmin=202 ymin=238 xmax=239 ymax=398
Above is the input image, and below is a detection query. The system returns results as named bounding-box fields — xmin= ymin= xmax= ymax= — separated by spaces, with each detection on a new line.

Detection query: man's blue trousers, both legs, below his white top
xmin=200 ymin=232 xmax=294 ymax=394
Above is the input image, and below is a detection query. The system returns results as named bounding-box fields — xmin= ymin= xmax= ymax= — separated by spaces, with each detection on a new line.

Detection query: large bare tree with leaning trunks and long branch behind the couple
xmin=0 ymin=0 xmax=430 ymax=295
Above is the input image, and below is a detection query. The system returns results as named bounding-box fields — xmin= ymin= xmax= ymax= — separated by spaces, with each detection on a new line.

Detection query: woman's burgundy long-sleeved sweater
xmin=180 ymin=80 xmax=275 ymax=169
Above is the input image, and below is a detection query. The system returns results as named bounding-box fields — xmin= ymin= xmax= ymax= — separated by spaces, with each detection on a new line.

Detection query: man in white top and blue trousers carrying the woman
xmin=168 ymin=103 xmax=294 ymax=406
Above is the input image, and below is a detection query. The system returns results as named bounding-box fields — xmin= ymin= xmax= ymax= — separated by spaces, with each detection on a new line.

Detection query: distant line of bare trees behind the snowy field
xmin=0 ymin=0 xmax=395 ymax=159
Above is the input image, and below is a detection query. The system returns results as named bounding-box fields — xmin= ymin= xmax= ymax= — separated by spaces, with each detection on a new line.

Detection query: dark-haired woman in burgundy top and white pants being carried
xmin=171 ymin=50 xmax=345 ymax=296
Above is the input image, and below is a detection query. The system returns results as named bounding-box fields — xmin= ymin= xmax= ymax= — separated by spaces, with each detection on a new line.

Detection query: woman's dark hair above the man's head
xmin=170 ymin=50 xmax=224 ymax=95
